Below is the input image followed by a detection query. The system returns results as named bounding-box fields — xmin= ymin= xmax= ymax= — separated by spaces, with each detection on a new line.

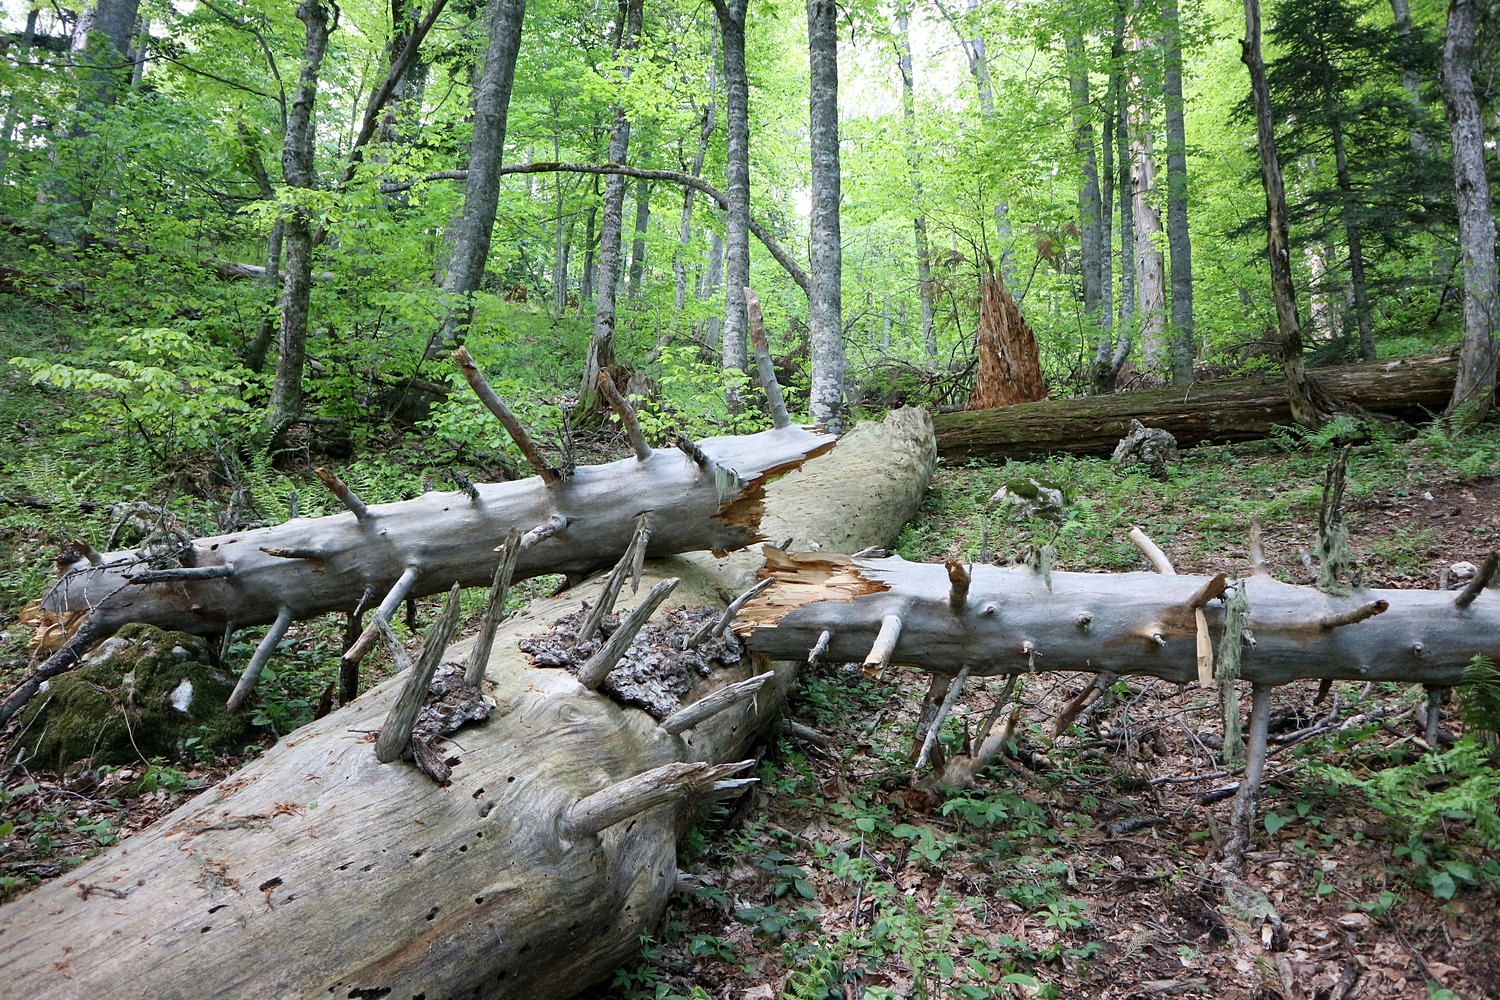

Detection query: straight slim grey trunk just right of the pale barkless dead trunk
xmin=1161 ymin=0 xmax=1196 ymax=385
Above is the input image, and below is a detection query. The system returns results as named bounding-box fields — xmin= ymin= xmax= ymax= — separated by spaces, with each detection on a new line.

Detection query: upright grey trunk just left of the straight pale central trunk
xmin=714 ymin=0 xmax=750 ymax=370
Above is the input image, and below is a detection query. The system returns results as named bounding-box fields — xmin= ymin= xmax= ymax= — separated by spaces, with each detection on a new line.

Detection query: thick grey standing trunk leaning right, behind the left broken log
xmin=429 ymin=0 xmax=527 ymax=357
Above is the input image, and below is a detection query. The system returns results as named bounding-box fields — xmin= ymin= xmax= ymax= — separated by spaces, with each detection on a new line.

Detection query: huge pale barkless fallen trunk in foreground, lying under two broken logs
xmin=0 ymin=411 xmax=935 ymax=1000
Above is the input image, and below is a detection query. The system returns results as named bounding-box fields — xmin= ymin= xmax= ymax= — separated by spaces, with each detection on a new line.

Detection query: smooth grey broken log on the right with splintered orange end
xmin=735 ymin=550 xmax=1500 ymax=687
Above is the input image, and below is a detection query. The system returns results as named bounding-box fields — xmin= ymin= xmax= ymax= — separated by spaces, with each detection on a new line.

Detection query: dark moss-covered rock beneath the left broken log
xmin=21 ymin=625 xmax=252 ymax=771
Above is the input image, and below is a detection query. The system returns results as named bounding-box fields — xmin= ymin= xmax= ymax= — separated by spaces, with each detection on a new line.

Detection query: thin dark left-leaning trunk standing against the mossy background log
xmin=1241 ymin=0 xmax=1331 ymax=427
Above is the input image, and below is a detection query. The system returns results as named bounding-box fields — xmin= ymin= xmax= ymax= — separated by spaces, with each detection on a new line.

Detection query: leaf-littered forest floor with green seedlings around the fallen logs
xmin=0 ymin=373 xmax=1500 ymax=1000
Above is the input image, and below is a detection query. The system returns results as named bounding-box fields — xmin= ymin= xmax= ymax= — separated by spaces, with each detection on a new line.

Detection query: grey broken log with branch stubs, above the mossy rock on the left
xmin=0 ymin=348 xmax=834 ymax=723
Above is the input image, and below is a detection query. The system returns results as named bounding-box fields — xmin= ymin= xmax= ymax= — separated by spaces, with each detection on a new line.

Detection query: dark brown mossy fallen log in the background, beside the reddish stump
xmin=933 ymin=355 xmax=1458 ymax=462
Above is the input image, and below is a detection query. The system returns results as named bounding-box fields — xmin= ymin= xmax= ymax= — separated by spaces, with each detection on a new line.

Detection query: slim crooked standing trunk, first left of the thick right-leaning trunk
xmin=266 ymin=0 xmax=338 ymax=441
